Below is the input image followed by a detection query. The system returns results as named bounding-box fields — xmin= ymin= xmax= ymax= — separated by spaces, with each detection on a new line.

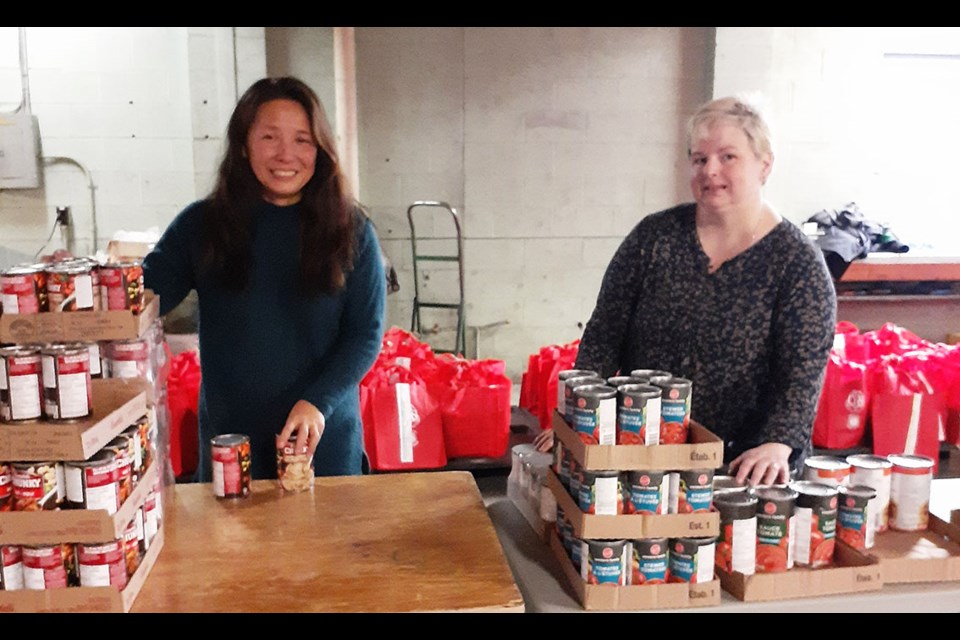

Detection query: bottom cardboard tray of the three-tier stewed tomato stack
xmin=550 ymin=531 xmax=720 ymax=611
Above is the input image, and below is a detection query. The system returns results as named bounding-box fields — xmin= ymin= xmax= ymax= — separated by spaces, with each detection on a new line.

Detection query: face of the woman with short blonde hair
xmin=690 ymin=119 xmax=773 ymax=218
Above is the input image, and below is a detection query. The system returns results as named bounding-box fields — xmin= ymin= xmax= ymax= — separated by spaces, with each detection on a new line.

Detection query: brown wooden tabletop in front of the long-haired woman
xmin=131 ymin=471 xmax=524 ymax=613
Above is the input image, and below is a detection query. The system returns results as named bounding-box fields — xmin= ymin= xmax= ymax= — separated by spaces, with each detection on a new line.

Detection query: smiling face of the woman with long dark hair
xmin=246 ymin=99 xmax=317 ymax=206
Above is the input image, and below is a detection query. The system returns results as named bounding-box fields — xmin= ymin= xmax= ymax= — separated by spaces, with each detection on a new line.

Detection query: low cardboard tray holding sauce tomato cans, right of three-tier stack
xmin=715 ymin=541 xmax=883 ymax=602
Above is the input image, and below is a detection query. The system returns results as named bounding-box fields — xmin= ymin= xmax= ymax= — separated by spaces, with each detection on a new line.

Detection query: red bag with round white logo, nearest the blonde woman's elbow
xmin=813 ymin=350 xmax=870 ymax=449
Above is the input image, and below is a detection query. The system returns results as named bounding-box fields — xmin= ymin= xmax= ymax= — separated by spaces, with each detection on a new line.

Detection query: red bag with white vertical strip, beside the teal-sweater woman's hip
xmin=360 ymin=366 xmax=447 ymax=471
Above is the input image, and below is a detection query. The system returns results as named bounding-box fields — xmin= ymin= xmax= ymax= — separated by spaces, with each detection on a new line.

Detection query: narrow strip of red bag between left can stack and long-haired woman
xmin=167 ymin=350 xmax=200 ymax=478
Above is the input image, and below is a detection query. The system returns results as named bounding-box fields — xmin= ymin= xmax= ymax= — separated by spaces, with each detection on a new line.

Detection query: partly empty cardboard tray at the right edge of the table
xmin=866 ymin=513 xmax=960 ymax=584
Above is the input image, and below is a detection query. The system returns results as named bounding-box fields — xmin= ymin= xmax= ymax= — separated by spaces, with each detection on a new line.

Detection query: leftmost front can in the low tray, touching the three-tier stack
xmin=713 ymin=491 xmax=757 ymax=576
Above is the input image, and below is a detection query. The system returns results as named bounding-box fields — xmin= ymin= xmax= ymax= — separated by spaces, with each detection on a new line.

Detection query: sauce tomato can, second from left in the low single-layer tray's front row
xmin=751 ymin=486 xmax=797 ymax=573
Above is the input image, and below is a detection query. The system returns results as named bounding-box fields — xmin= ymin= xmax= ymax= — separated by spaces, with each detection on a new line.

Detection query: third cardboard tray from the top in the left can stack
xmin=0 ymin=463 xmax=160 ymax=544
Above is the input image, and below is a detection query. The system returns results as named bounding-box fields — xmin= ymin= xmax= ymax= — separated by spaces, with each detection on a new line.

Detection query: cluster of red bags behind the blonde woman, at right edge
xmin=813 ymin=322 xmax=960 ymax=472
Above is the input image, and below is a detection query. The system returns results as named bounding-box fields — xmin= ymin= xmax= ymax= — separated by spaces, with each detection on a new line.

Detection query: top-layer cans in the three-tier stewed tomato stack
xmin=557 ymin=369 xmax=693 ymax=445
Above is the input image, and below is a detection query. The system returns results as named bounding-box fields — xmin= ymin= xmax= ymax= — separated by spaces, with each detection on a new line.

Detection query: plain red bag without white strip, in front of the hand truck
xmin=441 ymin=360 xmax=512 ymax=458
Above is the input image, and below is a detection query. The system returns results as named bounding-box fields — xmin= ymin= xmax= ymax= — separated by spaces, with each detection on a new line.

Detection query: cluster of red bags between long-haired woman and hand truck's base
xmin=360 ymin=327 xmax=512 ymax=471
